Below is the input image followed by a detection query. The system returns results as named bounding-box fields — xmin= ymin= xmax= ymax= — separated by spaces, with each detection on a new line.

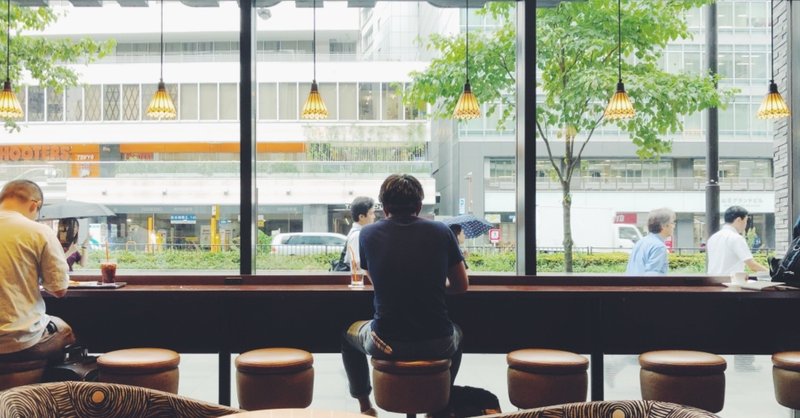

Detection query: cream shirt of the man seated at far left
xmin=0 ymin=210 xmax=69 ymax=354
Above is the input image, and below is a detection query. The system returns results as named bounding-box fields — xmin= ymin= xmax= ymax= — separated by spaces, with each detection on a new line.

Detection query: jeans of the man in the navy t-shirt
xmin=342 ymin=321 xmax=462 ymax=398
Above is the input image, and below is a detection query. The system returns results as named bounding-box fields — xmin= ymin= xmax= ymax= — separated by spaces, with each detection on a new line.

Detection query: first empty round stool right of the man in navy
xmin=506 ymin=348 xmax=589 ymax=409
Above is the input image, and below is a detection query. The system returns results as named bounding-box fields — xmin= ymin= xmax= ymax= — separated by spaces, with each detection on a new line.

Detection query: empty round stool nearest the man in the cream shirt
xmin=97 ymin=348 xmax=181 ymax=394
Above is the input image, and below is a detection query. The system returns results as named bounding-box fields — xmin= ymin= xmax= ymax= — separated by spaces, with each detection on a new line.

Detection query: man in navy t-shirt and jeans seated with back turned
xmin=342 ymin=174 xmax=469 ymax=415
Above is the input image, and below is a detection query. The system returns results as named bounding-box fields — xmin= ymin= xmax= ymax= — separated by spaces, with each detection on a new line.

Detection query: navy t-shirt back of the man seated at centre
xmin=360 ymin=216 xmax=464 ymax=341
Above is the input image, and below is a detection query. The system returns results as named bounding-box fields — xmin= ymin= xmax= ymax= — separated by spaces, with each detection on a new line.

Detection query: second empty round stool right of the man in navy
xmin=639 ymin=350 xmax=727 ymax=412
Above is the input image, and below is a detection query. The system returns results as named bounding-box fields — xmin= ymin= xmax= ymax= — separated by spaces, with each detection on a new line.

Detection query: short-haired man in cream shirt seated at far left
xmin=0 ymin=180 xmax=75 ymax=362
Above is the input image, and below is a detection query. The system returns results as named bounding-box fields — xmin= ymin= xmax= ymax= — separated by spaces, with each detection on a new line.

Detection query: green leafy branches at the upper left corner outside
xmin=0 ymin=4 xmax=114 ymax=131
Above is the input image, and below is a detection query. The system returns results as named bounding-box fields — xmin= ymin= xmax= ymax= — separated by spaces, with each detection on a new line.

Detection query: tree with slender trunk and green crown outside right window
xmin=405 ymin=0 xmax=736 ymax=272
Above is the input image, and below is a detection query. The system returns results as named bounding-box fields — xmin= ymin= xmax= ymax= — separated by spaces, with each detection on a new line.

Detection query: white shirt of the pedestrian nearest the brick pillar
xmin=706 ymin=224 xmax=753 ymax=276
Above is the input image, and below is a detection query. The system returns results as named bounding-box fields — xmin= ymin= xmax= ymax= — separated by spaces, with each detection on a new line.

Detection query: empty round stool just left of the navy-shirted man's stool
xmin=235 ymin=348 xmax=314 ymax=410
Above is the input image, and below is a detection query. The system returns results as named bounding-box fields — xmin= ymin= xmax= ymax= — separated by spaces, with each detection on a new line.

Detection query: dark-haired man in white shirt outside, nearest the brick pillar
xmin=706 ymin=206 xmax=768 ymax=276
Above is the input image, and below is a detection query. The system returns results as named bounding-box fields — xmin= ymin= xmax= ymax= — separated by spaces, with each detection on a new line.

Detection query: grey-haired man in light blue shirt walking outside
xmin=625 ymin=208 xmax=675 ymax=276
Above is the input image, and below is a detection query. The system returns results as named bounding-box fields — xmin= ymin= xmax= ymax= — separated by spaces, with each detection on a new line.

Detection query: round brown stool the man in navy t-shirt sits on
xmin=372 ymin=357 xmax=450 ymax=417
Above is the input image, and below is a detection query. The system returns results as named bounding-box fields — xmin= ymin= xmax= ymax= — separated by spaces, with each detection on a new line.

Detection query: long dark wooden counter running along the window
xmin=47 ymin=273 xmax=800 ymax=404
